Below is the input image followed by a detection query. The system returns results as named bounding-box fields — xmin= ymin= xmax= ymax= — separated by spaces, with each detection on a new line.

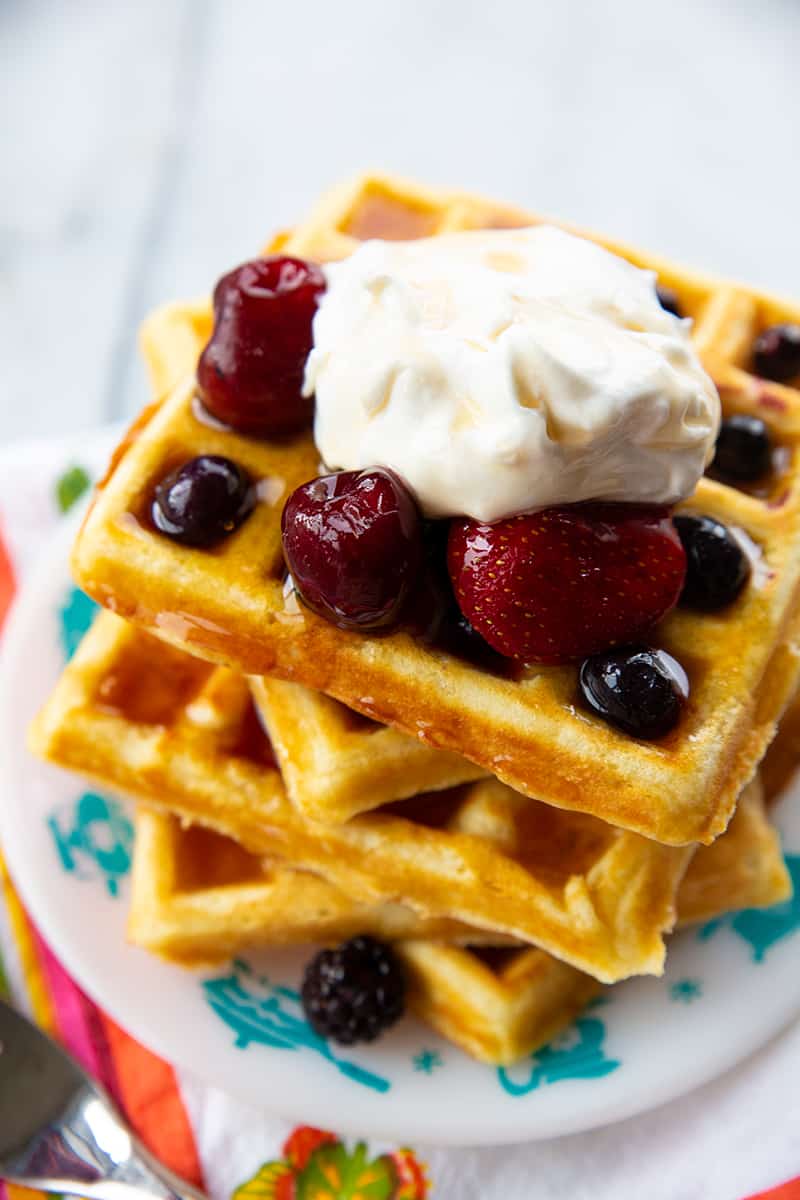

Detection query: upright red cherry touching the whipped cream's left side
xmin=197 ymin=257 xmax=325 ymax=437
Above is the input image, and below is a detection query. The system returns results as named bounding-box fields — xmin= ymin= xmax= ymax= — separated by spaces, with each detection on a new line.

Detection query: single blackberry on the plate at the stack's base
xmin=301 ymin=937 xmax=405 ymax=1045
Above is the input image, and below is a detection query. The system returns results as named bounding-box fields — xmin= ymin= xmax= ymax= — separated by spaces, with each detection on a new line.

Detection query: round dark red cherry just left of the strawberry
xmin=282 ymin=469 xmax=422 ymax=629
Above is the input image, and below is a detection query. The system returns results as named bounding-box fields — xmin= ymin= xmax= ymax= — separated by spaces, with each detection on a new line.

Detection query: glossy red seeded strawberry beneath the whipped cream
xmin=447 ymin=504 xmax=686 ymax=662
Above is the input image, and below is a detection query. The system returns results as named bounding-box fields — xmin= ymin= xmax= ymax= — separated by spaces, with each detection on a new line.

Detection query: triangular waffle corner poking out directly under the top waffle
xmin=251 ymin=676 xmax=486 ymax=824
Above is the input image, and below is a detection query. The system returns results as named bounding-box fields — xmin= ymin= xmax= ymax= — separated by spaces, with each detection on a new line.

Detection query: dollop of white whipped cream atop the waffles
xmin=305 ymin=226 xmax=720 ymax=522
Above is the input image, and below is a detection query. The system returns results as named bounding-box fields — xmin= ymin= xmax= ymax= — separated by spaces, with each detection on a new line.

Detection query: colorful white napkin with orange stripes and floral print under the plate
xmin=0 ymin=431 xmax=800 ymax=1200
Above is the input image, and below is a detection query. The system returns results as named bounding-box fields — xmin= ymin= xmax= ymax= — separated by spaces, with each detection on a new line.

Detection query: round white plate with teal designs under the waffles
xmin=0 ymin=527 xmax=800 ymax=1145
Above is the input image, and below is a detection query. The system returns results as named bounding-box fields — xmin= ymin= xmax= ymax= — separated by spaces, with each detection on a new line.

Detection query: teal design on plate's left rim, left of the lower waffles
xmin=47 ymin=792 xmax=133 ymax=896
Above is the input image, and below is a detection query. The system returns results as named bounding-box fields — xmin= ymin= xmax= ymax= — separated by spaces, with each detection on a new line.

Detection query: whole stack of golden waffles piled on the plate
xmin=32 ymin=176 xmax=800 ymax=1064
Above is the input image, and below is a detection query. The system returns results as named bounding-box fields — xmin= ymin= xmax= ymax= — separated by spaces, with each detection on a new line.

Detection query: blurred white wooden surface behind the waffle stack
xmin=0 ymin=0 xmax=800 ymax=440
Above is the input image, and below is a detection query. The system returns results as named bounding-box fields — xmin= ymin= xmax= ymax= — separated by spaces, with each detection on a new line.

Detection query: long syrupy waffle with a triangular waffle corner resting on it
xmin=31 ymin=613 xmax=692 ymax=983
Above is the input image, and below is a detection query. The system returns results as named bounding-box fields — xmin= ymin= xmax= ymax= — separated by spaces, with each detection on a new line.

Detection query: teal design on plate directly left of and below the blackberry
xmin=203 ymin=959 xmax=391 ymax=1092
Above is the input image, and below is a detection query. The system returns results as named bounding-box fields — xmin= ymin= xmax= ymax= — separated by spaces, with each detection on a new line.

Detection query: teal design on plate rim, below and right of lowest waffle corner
xmin=498 ymin=1016 xmax=621 ymax=1096
